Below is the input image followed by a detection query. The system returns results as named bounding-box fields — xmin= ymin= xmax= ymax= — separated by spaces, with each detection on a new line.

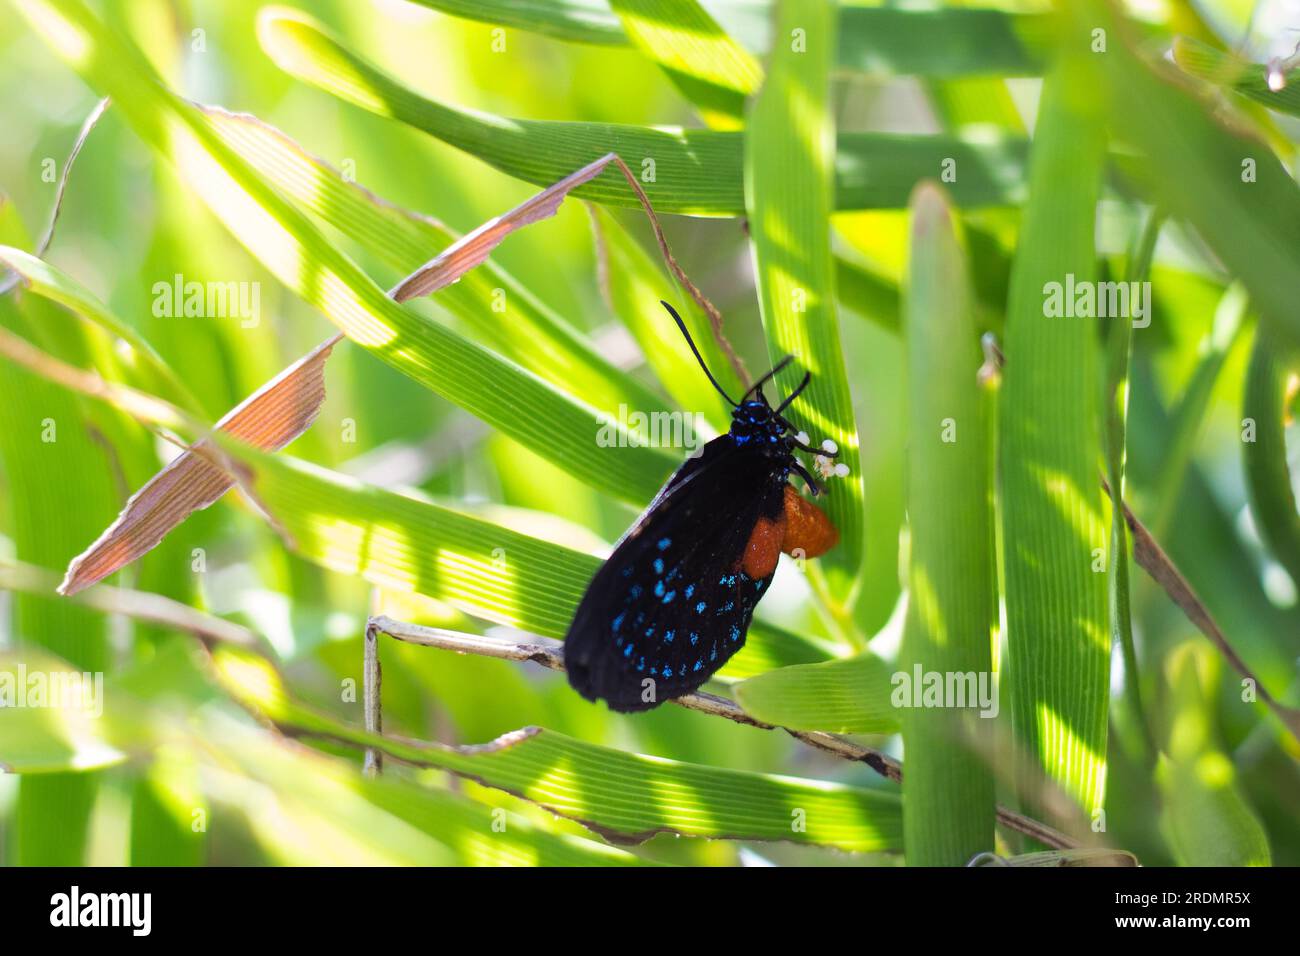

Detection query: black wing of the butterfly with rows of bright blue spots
xmin=564 ymin=434 xmax=785 ymax=711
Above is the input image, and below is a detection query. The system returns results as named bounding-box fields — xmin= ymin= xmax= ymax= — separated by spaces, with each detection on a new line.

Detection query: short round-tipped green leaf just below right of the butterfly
xmin=736 ymin=653 xmax=898 ymax=734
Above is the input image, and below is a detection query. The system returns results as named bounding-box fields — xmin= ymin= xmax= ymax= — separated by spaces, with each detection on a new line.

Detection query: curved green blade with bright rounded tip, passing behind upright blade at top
xmin=259 ymin=10 xmax=1026 ymax=216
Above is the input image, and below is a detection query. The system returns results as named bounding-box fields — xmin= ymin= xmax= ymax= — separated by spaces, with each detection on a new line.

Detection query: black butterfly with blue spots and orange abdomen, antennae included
xmin=564 ymin=302 xmax=837 ymax=711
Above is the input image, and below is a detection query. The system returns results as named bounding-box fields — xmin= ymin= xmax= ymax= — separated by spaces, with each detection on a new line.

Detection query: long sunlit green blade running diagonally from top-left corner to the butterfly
xmin=22 ymin=0 xmax=673 ymax=502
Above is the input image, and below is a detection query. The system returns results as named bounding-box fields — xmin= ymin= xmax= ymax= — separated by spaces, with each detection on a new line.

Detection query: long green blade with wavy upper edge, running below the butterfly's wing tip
xmin=215 ymin=648 xmax=901 ymax=852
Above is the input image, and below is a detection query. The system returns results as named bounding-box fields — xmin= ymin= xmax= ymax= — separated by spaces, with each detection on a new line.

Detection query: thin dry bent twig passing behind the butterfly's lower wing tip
xmin=365 ymin=615 xmax=1082 ymax=849
